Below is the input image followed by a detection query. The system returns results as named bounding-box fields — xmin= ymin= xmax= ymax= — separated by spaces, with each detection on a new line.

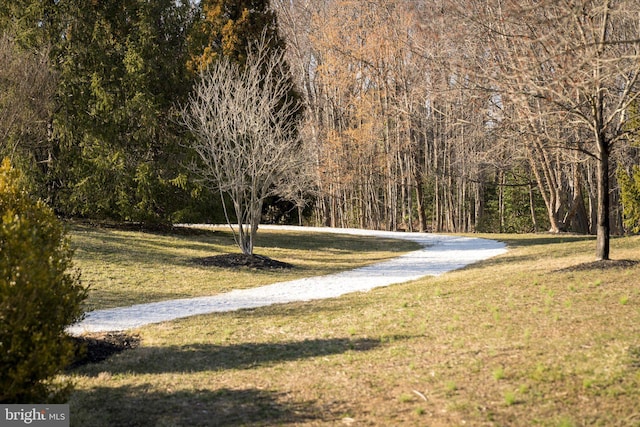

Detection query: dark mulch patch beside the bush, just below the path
xmin=69 ymin=332 xmax=140 ymax=369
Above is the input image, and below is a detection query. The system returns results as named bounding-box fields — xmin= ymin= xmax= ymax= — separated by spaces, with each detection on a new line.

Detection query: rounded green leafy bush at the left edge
xmin=0 ymin=159 xmax=86 ymax=403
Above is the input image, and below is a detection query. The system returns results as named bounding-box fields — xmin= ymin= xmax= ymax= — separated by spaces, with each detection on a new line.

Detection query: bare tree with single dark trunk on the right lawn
xmin=465 ymin=0 xmax=640 ymax=260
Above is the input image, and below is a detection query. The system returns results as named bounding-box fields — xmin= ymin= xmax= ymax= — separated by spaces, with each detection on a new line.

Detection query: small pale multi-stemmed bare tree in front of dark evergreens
xmin=182 ymin=37 xmax=311 ymax=255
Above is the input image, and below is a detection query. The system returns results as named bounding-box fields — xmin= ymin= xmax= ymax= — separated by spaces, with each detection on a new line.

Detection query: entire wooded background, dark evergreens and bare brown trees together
xmin=0 ymin=0 xmax=640 ymax=247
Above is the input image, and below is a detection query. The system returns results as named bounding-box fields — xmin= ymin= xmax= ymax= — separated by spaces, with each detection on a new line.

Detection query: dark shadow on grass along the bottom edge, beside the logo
xmin=71 ymin=385 xmax=323 ymax=427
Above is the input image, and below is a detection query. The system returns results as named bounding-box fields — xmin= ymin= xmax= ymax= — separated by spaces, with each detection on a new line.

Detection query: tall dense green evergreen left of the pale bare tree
xmin=56 ymin=0 xmax=198 ymax=226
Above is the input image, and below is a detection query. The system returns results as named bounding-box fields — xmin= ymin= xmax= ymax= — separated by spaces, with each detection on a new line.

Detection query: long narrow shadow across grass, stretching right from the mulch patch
xmin=75 ymin=338 xmax=380 ymax=375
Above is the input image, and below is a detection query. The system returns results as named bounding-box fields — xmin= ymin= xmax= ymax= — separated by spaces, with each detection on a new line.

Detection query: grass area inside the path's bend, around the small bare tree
xmin=71 ymin=225 xmax=419 ymax=311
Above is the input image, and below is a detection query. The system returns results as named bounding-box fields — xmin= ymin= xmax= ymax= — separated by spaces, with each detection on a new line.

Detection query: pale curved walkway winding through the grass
xmin=68 ymin=226 xmax=506 ymax=334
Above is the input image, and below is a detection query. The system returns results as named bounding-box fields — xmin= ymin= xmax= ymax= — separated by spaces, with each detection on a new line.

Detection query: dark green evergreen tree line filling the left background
xmin=0 ymin=0 xmax=281 ymax=224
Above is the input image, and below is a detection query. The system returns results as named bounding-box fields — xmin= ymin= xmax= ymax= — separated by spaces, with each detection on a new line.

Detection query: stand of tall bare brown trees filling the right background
xmin=274 ymin=0 xmax=640 ymax=259
